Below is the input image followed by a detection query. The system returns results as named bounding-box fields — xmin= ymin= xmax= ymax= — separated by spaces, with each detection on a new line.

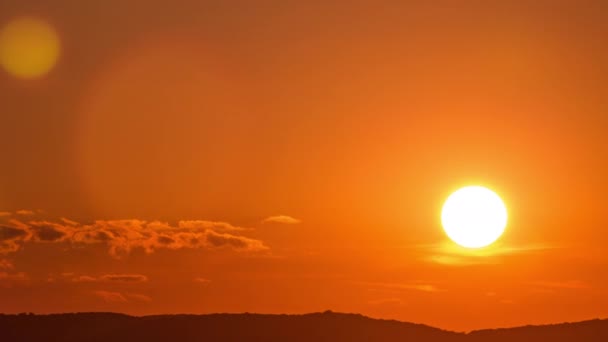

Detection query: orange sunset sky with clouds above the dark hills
xmin=0 ymin=0 xmax=608 ymax=330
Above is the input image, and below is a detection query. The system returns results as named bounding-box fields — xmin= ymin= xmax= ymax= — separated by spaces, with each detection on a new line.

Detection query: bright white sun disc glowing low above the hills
xmin=441 ymin=186 xmax=507 ymax=248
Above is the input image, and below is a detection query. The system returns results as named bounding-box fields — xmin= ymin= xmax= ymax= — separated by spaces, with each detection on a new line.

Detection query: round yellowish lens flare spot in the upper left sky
xmin=0 ymin=17 xmax=60 ymax=79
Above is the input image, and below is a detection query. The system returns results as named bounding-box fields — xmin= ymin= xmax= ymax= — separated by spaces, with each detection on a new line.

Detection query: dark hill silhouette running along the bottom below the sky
xmin=0 ymin=311 xmax=608 ymax=342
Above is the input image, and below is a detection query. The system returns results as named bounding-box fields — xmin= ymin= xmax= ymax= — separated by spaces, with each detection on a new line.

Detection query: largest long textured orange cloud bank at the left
xmin=0 ymin=212 xmax=268 ymax=258
